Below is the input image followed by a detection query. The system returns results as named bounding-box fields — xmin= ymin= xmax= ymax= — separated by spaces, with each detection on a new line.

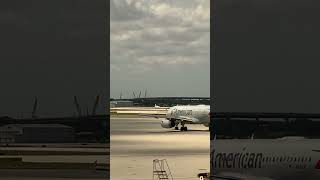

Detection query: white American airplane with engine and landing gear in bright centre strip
xmin=161 ymin=105 xmax=210 ymax=131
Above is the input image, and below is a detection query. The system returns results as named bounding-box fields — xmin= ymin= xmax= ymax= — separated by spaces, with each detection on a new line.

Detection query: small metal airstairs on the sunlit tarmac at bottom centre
xmin=152 ymin=159 xmax=173 ymax=180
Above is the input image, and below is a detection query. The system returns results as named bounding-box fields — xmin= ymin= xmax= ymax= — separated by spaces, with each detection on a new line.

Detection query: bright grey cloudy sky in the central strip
xmin=110 ymin=0 xmax=210 ymax=98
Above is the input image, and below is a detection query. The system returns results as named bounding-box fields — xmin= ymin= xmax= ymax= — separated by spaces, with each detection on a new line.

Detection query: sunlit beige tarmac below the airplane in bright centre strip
xmin=110 ymin=117 xmax=210 ymax=180
